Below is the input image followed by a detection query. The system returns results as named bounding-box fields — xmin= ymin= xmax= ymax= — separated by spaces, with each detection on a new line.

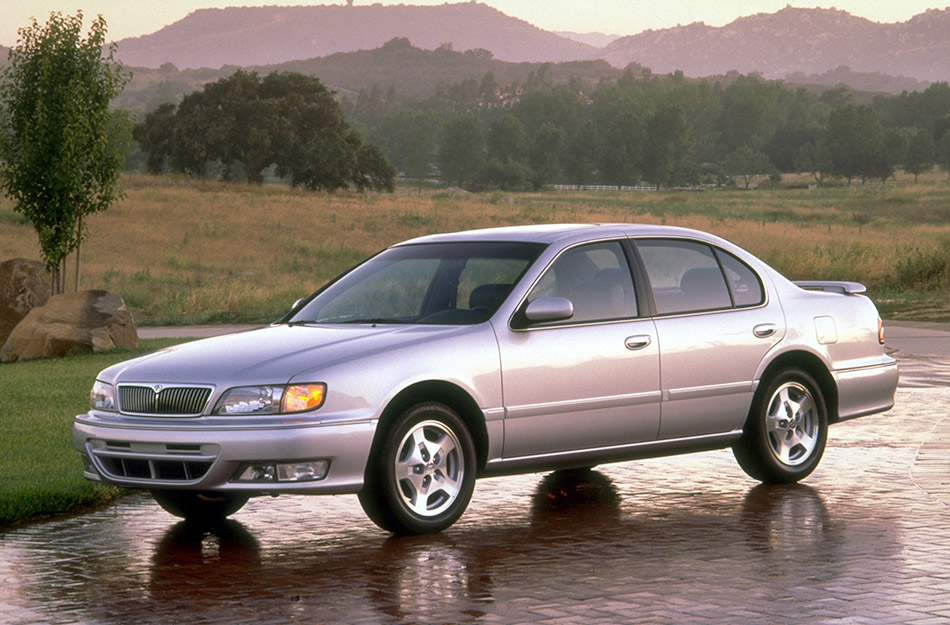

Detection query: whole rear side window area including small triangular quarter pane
xmin=636 ymin=239 xmax=763 ymax=315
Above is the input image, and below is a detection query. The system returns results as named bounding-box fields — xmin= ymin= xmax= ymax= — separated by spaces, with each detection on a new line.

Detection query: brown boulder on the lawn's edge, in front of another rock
xmin=0 ymin=291 xmax=139 ymax=362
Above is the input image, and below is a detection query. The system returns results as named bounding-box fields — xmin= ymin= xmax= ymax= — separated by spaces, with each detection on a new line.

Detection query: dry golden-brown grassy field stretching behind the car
xmin=0 ymin=174 xmax=950 ymax=325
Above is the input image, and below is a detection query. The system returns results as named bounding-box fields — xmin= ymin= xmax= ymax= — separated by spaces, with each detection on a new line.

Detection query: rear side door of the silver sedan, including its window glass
xmin=636 ymin=239 xmax=785 ymax=440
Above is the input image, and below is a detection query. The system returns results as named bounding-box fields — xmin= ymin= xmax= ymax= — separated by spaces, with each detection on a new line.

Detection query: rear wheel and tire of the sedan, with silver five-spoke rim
xmin=732 ymin=368 xmax=828 ymax=484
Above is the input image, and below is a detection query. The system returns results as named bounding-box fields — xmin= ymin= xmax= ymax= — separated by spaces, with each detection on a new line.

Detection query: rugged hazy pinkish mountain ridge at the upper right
xmin=601 ymin=6 xmax=950 ymax=81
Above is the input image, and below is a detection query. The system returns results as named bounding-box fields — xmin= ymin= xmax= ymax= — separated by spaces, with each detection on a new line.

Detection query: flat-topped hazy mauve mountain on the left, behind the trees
xmin=117 ymin=2 xmax=598 ymax=68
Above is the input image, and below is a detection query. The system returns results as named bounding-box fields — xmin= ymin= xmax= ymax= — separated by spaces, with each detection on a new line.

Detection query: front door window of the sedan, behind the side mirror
xmin=528 ymin=241 xmax=637 ymax=323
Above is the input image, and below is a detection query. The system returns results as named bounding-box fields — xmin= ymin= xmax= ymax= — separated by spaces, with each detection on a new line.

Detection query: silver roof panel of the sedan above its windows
xmin=399 ymin=223 xmax=721 ymax=245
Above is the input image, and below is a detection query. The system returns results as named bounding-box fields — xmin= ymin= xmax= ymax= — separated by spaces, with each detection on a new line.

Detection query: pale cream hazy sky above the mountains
xmin=0 ymin=0 xmax=947 ymax=46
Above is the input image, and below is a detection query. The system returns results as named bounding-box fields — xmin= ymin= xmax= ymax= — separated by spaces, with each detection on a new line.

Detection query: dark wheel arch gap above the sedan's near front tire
xmin=373 ymin=380 xmax=488 ymax=471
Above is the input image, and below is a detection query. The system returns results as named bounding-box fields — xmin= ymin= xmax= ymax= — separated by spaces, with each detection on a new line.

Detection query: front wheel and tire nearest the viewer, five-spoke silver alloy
xmin=359 ymin=402 xmax=476 ymax=534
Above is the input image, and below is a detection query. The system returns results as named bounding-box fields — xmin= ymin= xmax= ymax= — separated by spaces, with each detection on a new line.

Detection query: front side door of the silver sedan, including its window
xmin=498 ymin=241 xmax=660 ymax=458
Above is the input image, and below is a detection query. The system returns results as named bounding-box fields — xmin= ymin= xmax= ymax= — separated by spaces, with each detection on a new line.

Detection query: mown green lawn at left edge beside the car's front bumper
xmin=0 ymin=339 xmax=181 ymax=526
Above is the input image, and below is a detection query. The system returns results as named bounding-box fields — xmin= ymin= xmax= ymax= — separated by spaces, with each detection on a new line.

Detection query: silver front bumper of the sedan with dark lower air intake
xmin=72 ymin=413 xmax=376 ymax=494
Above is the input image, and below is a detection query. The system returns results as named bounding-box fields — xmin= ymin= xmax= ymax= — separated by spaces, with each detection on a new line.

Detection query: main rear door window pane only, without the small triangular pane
xmin=637 ymin=239 xmax=732 ymax=315
